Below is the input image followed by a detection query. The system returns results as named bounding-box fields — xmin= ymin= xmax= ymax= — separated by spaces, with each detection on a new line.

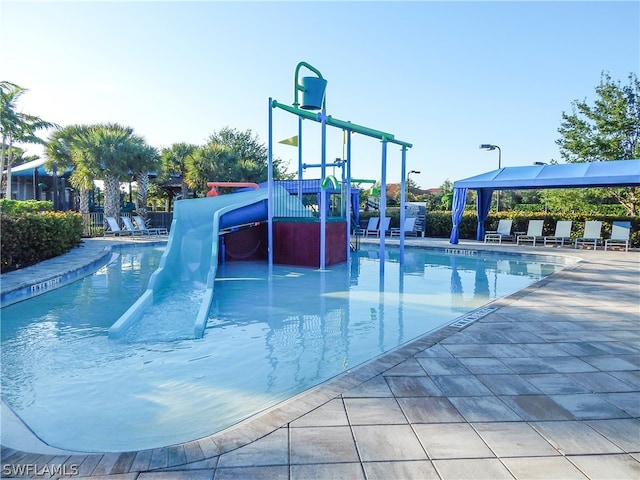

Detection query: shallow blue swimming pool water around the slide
xmin=2 ymin=246 xmax=561 ymax=451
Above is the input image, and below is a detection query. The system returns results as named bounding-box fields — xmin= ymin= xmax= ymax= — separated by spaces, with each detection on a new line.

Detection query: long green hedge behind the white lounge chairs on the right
xmin=360 ymin=209 xmax=640 ymax=247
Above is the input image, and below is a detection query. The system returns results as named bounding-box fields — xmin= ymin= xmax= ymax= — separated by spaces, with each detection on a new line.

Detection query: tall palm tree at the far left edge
xmin=0 ymin=81 xmax=56 ymax=198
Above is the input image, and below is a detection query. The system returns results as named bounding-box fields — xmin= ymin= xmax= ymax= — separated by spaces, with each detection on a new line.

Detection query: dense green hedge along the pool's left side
xmin=0 ymin=211 xmax=82 ymax=273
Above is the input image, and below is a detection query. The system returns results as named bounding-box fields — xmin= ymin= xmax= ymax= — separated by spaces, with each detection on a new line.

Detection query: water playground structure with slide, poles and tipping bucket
xmin=109 ymin=62 xmax=411 ymax=338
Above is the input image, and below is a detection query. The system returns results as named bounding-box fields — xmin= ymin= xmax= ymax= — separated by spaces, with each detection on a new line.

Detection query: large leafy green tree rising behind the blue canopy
xmin=547 ymin=73 xmax=640 ymax=215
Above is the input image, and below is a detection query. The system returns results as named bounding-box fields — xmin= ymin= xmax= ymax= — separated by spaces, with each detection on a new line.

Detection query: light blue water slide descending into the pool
xmin=109 ymin=187 xmax=270 ymax=338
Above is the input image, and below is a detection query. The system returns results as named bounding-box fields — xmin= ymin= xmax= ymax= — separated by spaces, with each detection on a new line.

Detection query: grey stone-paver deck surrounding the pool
xmin=0 ymin=237 xmax=640 ymax=480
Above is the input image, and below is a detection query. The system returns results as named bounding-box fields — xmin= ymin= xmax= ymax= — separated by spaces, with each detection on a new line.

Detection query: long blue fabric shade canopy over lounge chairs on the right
xmin=449 ymin=160 xmax=640 ymax=244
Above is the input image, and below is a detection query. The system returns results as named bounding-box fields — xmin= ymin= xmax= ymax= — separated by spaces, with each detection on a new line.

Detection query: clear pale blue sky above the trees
xmin=0 ymin=0 xmax=640 ymax=188
